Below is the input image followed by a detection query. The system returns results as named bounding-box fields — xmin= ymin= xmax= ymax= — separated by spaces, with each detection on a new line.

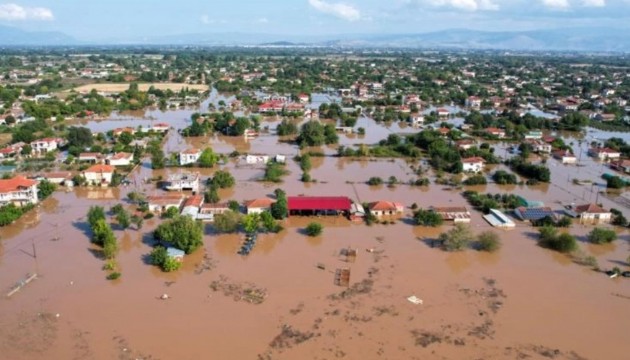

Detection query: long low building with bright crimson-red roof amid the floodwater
xmin=287 ymin=196 xmax=352 ymax=215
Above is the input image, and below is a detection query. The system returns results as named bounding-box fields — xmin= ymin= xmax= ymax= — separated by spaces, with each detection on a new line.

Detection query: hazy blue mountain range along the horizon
xmin=0 ymin=26 xmax=630 ymax=52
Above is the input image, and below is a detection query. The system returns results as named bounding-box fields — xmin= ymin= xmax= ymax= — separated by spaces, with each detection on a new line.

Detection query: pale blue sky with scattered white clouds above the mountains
xmin=0 ymin=0 xmax=630 ymax=40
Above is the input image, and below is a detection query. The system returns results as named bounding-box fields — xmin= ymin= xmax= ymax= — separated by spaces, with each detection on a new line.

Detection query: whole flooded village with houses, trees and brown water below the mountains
xmin=0 ymin=49 xmax=630 ymax=360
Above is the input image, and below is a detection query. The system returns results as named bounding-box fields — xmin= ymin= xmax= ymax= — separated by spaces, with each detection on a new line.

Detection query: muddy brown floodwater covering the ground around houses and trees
xmin=0 ymin=95 xmax=630 ymax=360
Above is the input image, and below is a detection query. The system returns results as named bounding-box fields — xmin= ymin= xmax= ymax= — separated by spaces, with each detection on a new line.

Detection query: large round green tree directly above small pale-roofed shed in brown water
xmin=153 ymin=216 xmax=203 ymax=254
